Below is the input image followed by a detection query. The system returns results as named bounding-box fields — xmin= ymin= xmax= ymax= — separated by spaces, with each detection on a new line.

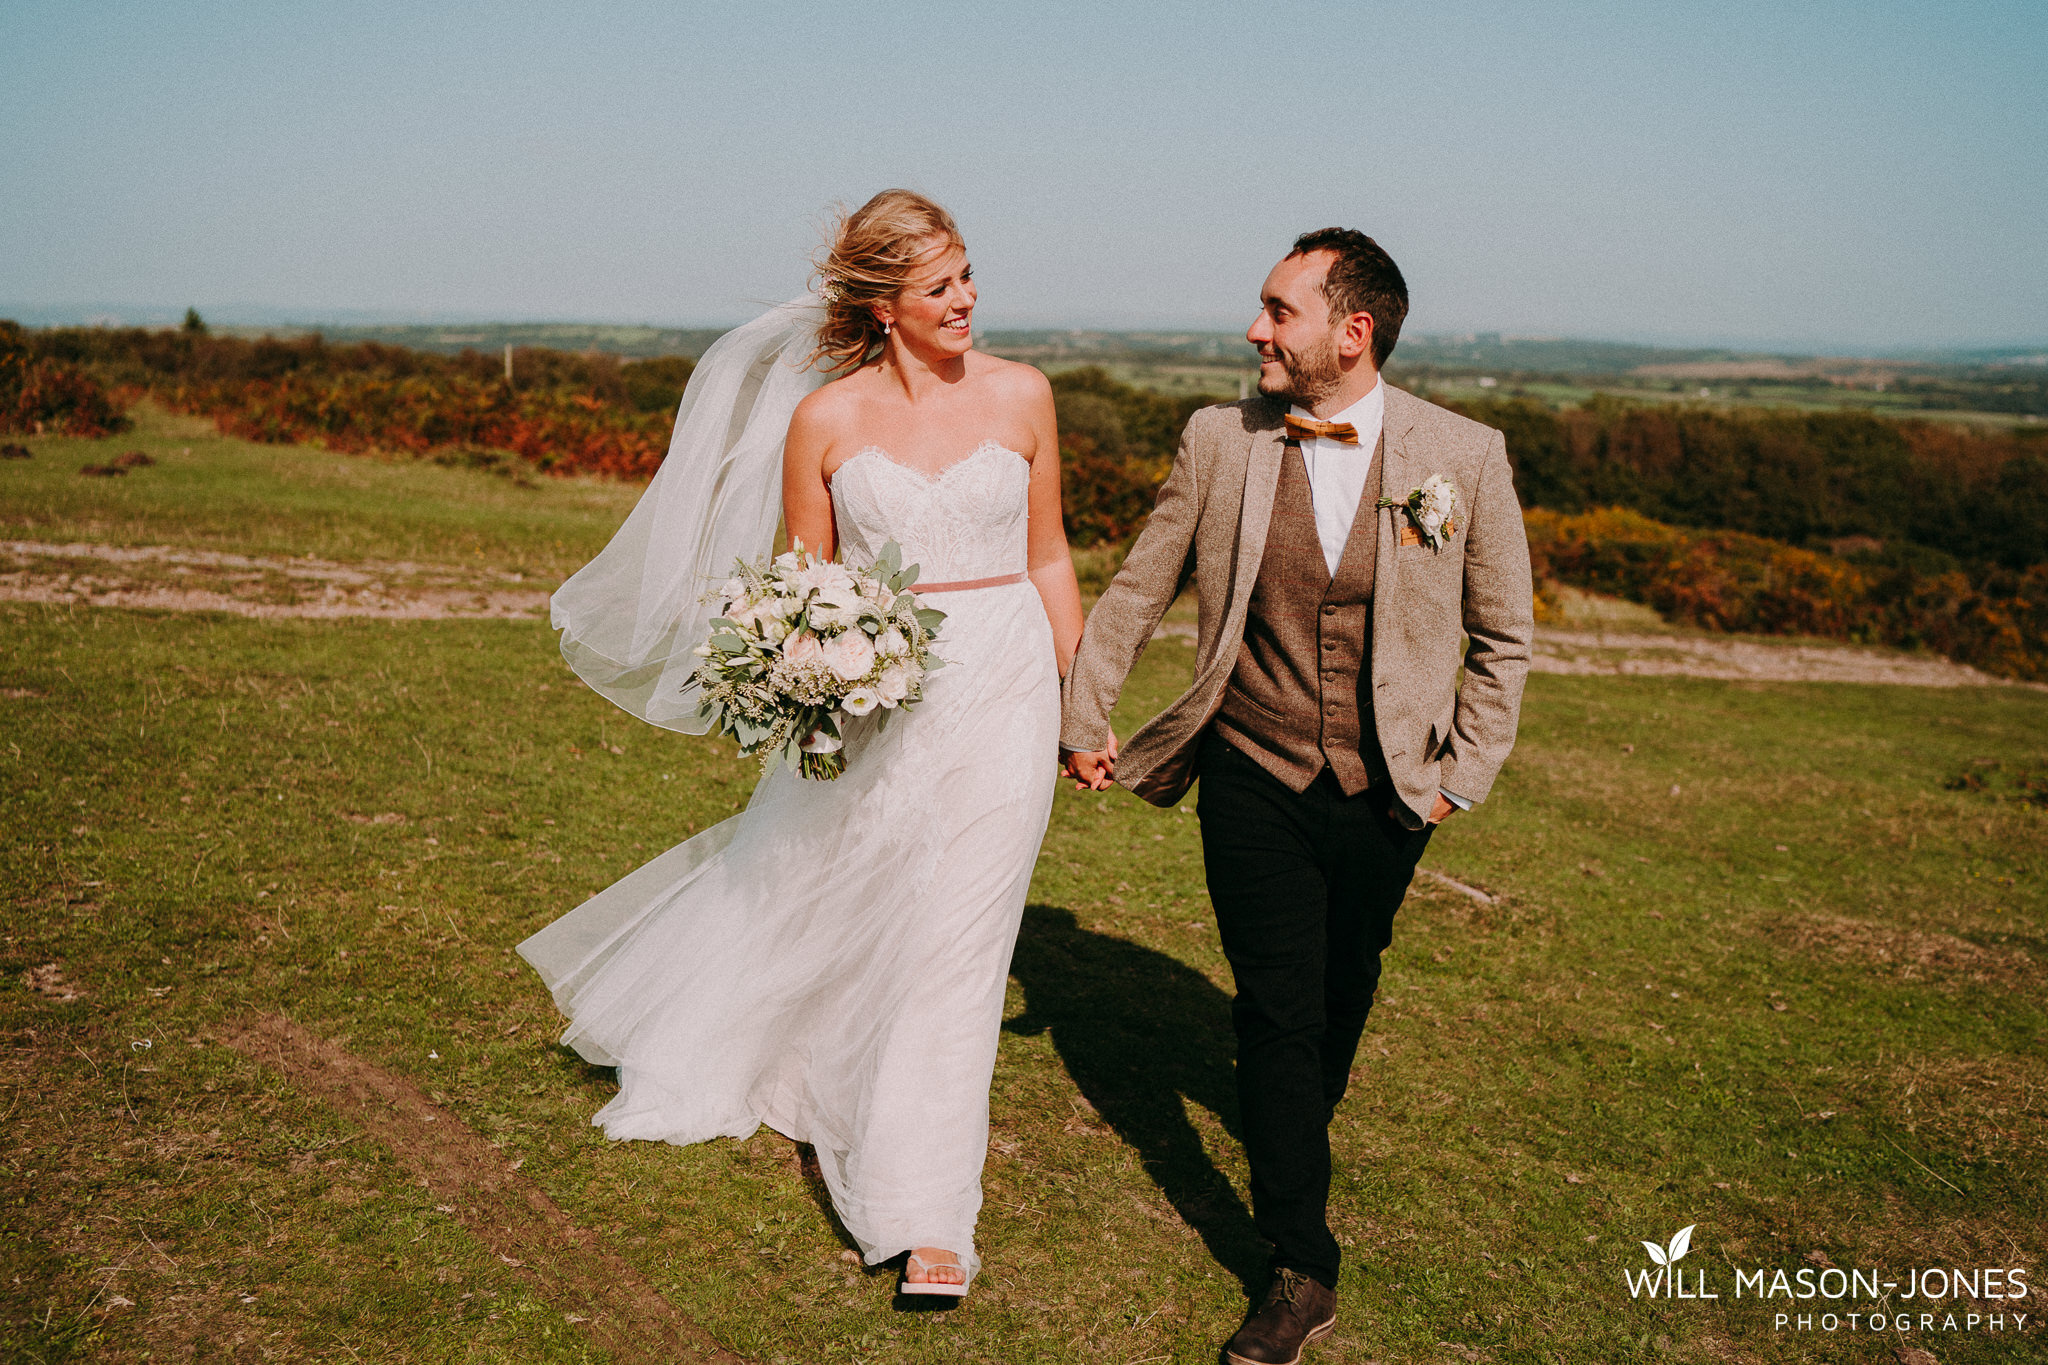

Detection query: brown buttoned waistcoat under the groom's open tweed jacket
xmin=1217 ymin=442 xmax=1386 ymax=796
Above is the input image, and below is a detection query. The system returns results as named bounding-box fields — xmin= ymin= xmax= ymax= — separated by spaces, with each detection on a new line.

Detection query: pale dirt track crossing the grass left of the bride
xmin=0 ymin=540 xmax=549 ymax=620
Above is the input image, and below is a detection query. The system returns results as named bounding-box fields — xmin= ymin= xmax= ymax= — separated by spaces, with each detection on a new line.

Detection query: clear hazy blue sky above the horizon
xmin=0 ymin=0 xmax=2048 ymax=350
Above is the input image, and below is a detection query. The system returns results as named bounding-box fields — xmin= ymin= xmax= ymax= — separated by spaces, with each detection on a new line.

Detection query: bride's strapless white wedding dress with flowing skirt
xmin=520 ymin=442 xmax=1059 ymax=1269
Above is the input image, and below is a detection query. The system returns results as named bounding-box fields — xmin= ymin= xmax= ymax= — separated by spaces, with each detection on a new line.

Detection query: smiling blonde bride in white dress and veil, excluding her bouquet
xmin=520 ymin=190 xmax=1081 ymax=1295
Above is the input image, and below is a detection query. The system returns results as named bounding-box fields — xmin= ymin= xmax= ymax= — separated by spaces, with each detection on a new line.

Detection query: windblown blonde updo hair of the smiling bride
xmin=811 ymin=190 xmax=967 ymax=370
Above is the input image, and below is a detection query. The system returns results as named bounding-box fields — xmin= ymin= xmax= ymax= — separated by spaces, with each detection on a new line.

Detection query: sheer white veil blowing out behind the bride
xmin=549 ymin=295 xmax=825 ymax=735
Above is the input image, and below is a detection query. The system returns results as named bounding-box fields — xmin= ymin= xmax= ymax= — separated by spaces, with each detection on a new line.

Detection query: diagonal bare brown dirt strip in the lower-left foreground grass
xmin=225 ymin=1015 xmax=748 ymax=1365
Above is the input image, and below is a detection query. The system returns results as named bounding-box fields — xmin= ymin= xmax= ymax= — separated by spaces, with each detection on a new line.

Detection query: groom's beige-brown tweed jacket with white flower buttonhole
xmin=1061 ymin=385 xmax=1534 ymax=827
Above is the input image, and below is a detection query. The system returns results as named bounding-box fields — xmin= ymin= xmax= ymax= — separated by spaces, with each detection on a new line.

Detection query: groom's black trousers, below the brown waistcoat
xmin=1198 ymin=733 xmax=1434 ymax=1289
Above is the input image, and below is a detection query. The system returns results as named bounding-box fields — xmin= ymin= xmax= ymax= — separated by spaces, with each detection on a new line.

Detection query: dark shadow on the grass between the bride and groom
xmin=1004 ymin=905 xmax=1266 ymax=1293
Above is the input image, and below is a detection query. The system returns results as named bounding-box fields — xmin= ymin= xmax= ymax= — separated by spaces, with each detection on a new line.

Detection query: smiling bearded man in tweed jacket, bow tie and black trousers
xmin=1061 ymin=227 xmax=1534 ymax=1365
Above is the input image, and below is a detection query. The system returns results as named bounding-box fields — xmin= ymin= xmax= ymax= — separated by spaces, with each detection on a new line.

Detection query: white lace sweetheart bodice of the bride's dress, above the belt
xmin=831 ymin=440 xmax=1030 ymax=583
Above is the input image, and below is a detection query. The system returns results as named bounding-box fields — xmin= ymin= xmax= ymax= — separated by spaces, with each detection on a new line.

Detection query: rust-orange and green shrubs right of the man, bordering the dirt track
xmin=1524 ymin=508 xmax=2048 ymax=679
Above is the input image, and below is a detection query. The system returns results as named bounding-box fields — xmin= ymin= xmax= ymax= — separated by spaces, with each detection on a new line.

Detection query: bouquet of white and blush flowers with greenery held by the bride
xmin=692 ymin=540 xmax=946 ymax=780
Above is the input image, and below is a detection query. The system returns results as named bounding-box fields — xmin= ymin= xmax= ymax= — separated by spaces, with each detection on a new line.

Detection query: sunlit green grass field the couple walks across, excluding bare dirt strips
xmin=0 ymin=417 xmax=2048 ymax=1365
